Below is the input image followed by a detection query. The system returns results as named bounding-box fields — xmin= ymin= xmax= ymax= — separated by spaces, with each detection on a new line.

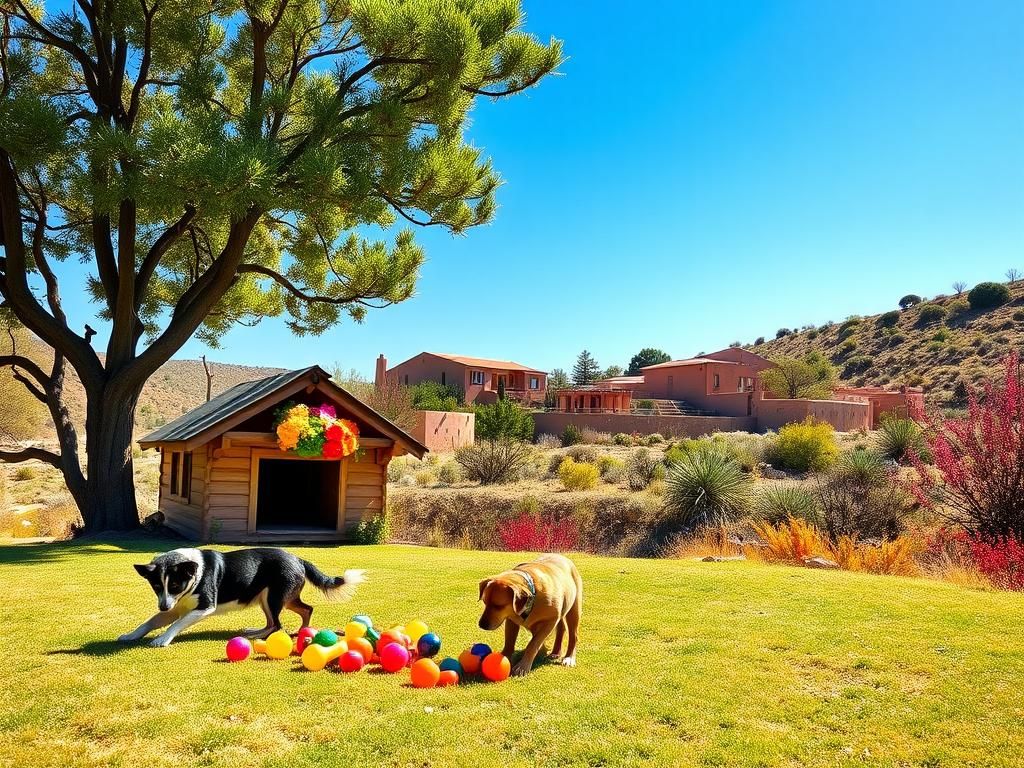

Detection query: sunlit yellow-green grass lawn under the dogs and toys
xmin=0 ymin=540 xmax=1024 ymax=768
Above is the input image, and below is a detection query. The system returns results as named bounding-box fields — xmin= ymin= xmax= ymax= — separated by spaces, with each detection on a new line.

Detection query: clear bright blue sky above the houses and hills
xmin=58 ymin=0 xmax=1024 ymax=374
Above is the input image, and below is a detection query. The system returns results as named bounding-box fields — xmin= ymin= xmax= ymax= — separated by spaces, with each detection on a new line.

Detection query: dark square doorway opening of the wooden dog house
xmin=256 ymin=458 xmax=341 ymax=532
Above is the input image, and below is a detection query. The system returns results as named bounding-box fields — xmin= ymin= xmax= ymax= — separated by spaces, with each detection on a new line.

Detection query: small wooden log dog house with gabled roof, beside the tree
xmin=138 ymin=366 xmax=427 ymax=543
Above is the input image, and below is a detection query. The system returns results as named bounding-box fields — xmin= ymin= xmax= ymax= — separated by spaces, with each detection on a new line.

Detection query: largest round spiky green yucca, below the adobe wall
xmin=666 ymin=451 xmax=753 ymax=528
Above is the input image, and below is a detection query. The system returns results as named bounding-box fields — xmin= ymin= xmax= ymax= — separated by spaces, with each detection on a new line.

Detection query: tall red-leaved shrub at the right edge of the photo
xmin=910 ymin=353 xmax=1024 ymax=543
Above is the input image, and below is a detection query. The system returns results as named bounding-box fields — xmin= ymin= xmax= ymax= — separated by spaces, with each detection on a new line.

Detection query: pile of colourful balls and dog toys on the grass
xmin=225 ymin=614 xmax=511 ymax=688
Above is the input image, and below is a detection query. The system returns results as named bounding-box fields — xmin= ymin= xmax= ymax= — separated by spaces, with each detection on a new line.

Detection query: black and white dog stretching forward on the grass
xmin=118 ymin=547 xmax=366 ymax=648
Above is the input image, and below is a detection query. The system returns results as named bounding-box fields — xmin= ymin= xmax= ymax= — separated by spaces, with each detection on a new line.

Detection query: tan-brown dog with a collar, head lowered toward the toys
xmin=480 ymin=555 xmax=583 ymax=677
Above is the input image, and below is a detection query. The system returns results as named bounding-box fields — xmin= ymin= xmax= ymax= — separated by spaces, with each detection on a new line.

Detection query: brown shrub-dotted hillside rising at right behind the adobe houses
xmin=746 ymin=282 xmax=1024 ymax=406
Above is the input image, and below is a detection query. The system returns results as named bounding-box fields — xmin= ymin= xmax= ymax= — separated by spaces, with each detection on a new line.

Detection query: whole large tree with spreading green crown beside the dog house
xmin=0 ymin=0 xmax=562 ymax=530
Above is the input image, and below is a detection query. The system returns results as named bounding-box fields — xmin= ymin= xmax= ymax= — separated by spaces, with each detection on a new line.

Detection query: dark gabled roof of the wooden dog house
xmin=138 ymin=366 xmax=427 ymax=457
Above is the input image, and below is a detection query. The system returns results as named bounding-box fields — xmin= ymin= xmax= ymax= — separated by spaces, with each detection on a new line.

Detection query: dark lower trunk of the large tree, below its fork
xmin=80 ymin=385 xmax=141 ymax=532
